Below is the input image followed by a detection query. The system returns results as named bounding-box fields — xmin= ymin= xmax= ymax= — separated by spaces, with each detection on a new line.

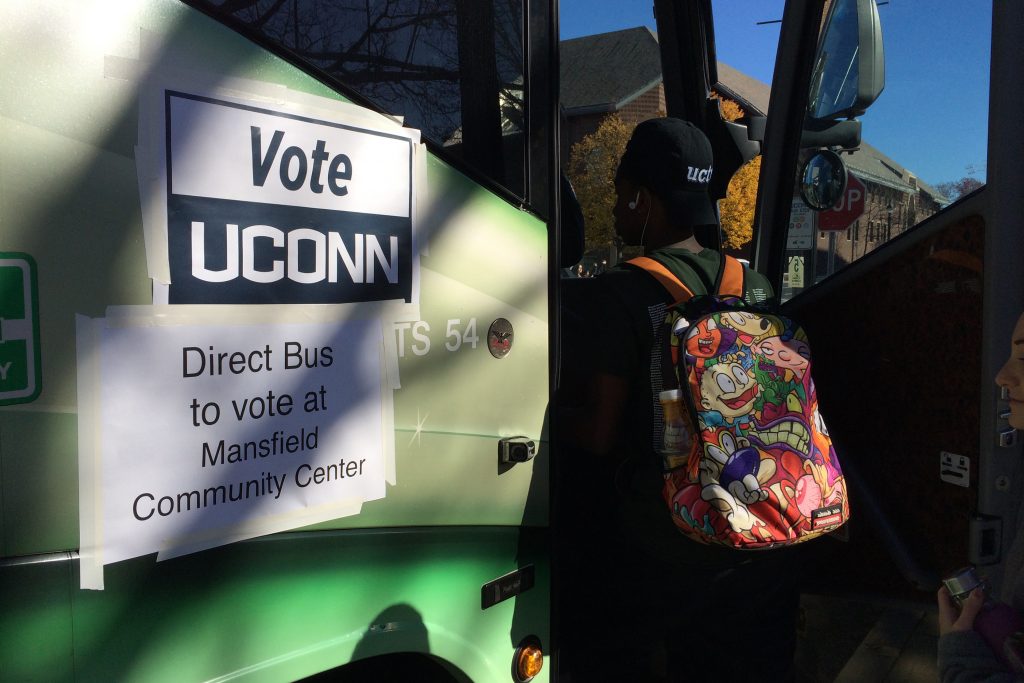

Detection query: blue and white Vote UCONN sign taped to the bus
xmin=165 ymin=91 xmax=413 ymax=304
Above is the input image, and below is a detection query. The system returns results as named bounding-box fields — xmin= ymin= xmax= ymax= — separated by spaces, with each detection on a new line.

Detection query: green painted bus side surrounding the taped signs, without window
xmin=0 ymin=0 xmax=549 ymax=681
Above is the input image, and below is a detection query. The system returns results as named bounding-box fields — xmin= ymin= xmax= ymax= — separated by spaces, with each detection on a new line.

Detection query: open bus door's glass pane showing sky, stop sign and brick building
xmin=781 ymin=3 xmax=991 ymax=300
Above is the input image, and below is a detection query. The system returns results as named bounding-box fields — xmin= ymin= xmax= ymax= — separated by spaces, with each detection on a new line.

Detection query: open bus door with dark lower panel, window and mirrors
xmin=755 ymin=0 xmax=1024 ymax=601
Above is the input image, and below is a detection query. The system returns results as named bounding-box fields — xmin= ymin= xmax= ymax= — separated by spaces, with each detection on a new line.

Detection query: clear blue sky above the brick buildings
xmin=560 ymin=0 xmax=991 ymax=184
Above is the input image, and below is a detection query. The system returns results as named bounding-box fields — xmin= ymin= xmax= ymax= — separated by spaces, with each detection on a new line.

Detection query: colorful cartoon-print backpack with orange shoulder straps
xmin=630 ymin=256 xmax=850 ymax=549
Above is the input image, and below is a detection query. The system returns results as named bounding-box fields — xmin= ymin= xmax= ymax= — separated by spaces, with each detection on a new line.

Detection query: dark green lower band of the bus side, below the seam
xmin=0 ymin=527 xmax=548 ymax=681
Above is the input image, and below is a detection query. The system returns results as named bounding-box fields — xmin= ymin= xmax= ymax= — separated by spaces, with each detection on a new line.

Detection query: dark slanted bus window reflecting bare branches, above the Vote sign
xmin=197 ymin=0 xmax=527 ymax=199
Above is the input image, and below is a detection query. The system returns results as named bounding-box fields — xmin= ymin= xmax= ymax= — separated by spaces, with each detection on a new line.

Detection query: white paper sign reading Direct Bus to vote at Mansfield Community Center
xmin=79 ymin=309 xmax=393 ymax=588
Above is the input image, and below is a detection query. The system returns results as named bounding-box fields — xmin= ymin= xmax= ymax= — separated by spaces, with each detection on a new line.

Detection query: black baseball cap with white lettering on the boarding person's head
xmin=616 ymin=118 xmax=718 ymax=225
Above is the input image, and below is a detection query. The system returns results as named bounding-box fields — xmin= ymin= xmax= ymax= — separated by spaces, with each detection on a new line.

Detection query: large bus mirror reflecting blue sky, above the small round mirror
xmin=807 ymin=0 xmax=886 ymax=121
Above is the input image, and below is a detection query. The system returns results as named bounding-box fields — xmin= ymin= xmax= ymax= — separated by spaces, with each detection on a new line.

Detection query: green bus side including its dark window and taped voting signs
xmin=0 ymin=0 xmax=553 ymax=681
